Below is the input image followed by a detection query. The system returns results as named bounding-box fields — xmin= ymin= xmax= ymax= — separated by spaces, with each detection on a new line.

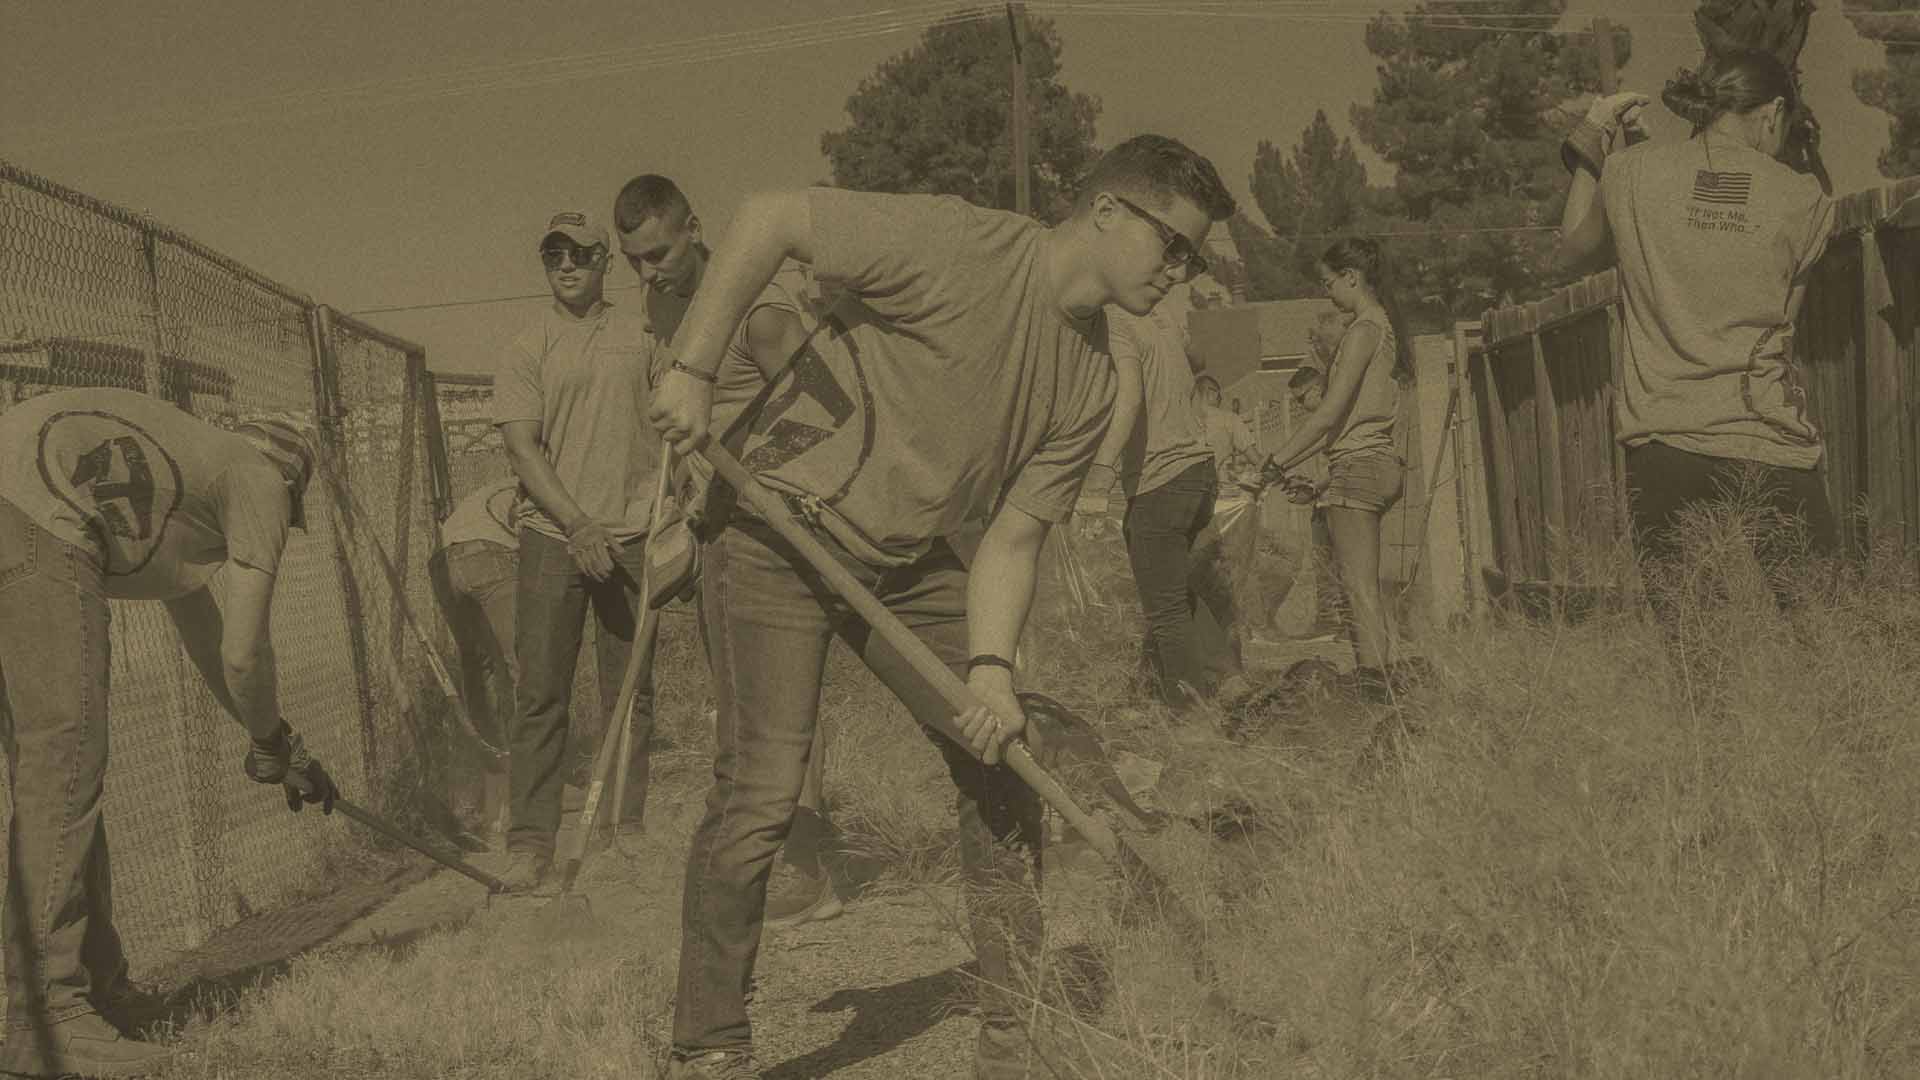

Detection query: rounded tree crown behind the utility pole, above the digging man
xmin=820 ymin=15 xmax=1100 ymax=221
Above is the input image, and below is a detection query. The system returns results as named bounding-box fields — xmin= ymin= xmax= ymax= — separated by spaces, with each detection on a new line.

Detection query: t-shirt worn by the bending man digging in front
xmin=743 ymin=188 xmax=1114 ymax=565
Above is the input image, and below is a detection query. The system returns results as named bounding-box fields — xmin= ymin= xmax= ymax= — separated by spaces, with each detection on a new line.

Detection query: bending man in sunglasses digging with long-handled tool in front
xmin=649 ymin=135 xmax=1233 ymax=1080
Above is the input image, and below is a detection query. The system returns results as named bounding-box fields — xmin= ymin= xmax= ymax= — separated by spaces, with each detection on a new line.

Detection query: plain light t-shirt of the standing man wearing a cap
xmin=493 ymin=304 xmax=660 ymax=544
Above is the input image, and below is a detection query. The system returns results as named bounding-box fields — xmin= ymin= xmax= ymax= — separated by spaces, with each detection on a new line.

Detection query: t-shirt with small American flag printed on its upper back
xmin=1599 ymin=135 xmax=1834 ymax=469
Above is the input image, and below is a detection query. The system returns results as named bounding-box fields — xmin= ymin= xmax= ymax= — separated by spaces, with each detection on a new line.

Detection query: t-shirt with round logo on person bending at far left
xmin=0 ymin=390 xmax=291 ymax=600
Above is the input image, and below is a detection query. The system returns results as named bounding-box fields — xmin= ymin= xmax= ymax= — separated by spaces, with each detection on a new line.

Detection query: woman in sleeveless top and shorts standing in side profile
xmin=1267 ymin=236 xmax=1413 ymax=701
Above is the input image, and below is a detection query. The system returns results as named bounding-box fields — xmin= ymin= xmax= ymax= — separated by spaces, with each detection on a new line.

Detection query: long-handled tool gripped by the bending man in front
xmin=701 ymin=442 xmax=1275 ymax=1034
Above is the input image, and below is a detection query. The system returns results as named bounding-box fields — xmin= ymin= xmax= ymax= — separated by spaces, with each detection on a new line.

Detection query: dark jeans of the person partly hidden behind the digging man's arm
xmin=1121 ymin=459 xmax=1240 ymax=705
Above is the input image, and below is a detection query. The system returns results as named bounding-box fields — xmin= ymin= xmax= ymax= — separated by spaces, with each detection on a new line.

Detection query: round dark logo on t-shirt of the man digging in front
xmin=741 ymin=315 xmax=874 ymax=503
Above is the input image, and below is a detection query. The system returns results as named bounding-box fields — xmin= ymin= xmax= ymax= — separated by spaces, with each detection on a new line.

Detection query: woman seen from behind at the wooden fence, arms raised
xmin=1557 ymin=52 xmax=1836 ymax=580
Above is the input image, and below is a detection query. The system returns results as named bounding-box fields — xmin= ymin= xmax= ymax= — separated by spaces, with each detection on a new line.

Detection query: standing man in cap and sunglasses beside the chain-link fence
xmin=493 ymin=211 xmax=660 ymax=890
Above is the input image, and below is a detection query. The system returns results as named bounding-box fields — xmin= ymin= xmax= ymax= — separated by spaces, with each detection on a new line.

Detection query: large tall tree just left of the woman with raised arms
xmin=1352 ymin=0 xmax=1632 ymax=321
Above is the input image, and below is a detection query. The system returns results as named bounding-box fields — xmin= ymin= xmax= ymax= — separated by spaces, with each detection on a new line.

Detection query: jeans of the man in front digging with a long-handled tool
xmin=674 ymin=515 xmax=1041 ymax=1053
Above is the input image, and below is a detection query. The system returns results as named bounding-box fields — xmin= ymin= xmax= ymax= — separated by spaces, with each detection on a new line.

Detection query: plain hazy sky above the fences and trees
xmin=0 ymin=0 xmax=1887 ymax=371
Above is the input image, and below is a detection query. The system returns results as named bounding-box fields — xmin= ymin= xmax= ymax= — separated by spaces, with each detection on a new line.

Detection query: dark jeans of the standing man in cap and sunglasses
xmin=507 ymin=528 xmax=653 ymax=857
